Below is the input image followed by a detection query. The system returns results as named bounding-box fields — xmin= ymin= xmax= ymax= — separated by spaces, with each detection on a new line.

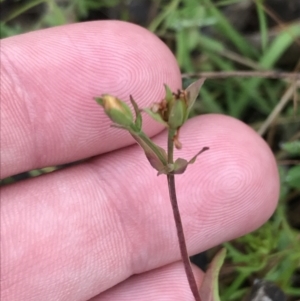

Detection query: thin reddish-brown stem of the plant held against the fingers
xmin=167 ymin=130 xmax=201 ymax=301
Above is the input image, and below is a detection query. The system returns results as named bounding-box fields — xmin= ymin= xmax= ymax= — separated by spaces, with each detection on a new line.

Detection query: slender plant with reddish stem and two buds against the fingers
xmin=95 ymin=79 xmax=224 ymax=301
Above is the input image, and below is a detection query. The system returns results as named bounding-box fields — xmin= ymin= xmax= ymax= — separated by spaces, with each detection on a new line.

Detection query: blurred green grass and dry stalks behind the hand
xmin=0 ymin=0 xmax=300 ymax=301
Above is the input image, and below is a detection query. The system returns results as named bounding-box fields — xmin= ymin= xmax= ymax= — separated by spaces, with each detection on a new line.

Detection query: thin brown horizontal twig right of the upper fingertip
xmin=181 ymin=71 xmax=300 ymax=80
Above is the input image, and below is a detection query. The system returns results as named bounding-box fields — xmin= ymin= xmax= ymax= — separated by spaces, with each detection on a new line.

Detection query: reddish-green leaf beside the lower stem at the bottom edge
xmin=199 ymin=248 xmax=226 ymax=301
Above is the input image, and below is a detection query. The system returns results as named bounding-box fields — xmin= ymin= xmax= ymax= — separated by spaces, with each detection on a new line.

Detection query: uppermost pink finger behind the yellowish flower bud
xmin=1 ymin=21 xmax=181 ymax=178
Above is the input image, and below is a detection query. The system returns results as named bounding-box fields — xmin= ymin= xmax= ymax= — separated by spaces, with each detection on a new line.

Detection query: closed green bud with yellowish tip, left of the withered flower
xmin=96 ymin=94 xmax=134 ymax=127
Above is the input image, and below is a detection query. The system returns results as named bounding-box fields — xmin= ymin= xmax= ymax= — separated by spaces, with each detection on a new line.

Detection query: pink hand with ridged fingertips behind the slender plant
xmin=1 ymin=21 xmax=279 ymax=301
